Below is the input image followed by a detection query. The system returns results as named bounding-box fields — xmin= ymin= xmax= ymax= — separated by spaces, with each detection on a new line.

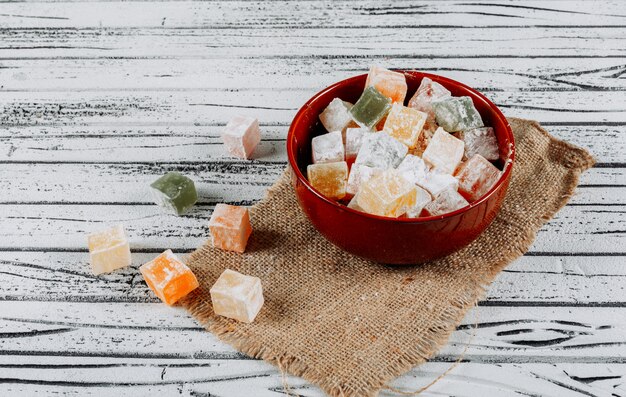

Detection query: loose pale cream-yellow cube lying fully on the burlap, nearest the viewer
xmin=209 ymin=269 xmax=264 ymax=323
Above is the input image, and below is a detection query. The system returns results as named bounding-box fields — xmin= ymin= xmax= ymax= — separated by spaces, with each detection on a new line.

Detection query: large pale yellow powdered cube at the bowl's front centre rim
xmin=357 ymin=169 xmax=416 ymax=218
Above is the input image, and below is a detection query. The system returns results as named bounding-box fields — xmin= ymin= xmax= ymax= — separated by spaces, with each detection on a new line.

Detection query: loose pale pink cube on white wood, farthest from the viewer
xmin=222 ymin=116 xmax=261 ymax=159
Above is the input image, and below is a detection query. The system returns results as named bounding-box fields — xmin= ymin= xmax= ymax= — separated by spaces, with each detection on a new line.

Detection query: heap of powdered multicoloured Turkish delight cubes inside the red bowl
xmin=307 ymin=66 xmax=501 ymax=218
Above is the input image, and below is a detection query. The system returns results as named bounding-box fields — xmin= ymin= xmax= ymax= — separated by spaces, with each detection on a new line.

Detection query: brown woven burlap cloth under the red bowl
xmin=182 ymin=118 xmax=594 ymax=396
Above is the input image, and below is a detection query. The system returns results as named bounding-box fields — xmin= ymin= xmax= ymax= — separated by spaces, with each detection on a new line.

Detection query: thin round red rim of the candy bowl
xmin=287 ymin=69 xmax=515 ymax=224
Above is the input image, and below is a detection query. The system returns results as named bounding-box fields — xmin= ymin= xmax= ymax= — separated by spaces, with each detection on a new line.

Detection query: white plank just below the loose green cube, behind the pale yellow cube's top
xmin=0 ymin=203 xmax=626 ymax=253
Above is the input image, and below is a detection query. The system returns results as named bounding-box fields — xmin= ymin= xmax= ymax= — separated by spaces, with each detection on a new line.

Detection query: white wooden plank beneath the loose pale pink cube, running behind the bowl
xmin=0 ymin=124 xmax=626 ymax=164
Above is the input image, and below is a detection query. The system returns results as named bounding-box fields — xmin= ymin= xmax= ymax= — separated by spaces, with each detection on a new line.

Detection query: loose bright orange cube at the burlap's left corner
xmin=139 ymin=250 xmax=198 ymax=305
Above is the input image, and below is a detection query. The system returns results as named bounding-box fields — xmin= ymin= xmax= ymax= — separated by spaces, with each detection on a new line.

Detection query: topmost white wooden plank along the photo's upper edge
xmin=0 ymin=0 xmax=626 ymax=30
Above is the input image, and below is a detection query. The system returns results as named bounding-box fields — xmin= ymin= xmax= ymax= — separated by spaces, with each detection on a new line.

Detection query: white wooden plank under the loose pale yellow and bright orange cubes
xmin=0 ymin=251 xmax=626 ymax=306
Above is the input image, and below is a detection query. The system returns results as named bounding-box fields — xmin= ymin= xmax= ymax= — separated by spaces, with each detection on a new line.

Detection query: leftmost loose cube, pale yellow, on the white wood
xmin=87 ymin=225 xmax=131 ymax=275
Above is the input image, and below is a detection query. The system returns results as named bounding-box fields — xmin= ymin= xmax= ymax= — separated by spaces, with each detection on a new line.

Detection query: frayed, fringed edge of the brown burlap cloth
xmin=181 ymin=118 xmax=595 ymax=397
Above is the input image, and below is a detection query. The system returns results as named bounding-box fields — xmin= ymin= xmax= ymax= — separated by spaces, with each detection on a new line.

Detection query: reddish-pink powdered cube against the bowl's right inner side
xmin=456 ymin=154 xmax=500 ymax=201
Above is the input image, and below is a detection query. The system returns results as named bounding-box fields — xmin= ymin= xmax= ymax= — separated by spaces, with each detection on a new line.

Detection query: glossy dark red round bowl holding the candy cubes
xmin=287 ymin=71 xmax=515 ymax=264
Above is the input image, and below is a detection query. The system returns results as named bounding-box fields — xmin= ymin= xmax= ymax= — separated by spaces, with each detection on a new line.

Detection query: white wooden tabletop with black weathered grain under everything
xmin=0 ymin=0 xmax=626 ymax=397
